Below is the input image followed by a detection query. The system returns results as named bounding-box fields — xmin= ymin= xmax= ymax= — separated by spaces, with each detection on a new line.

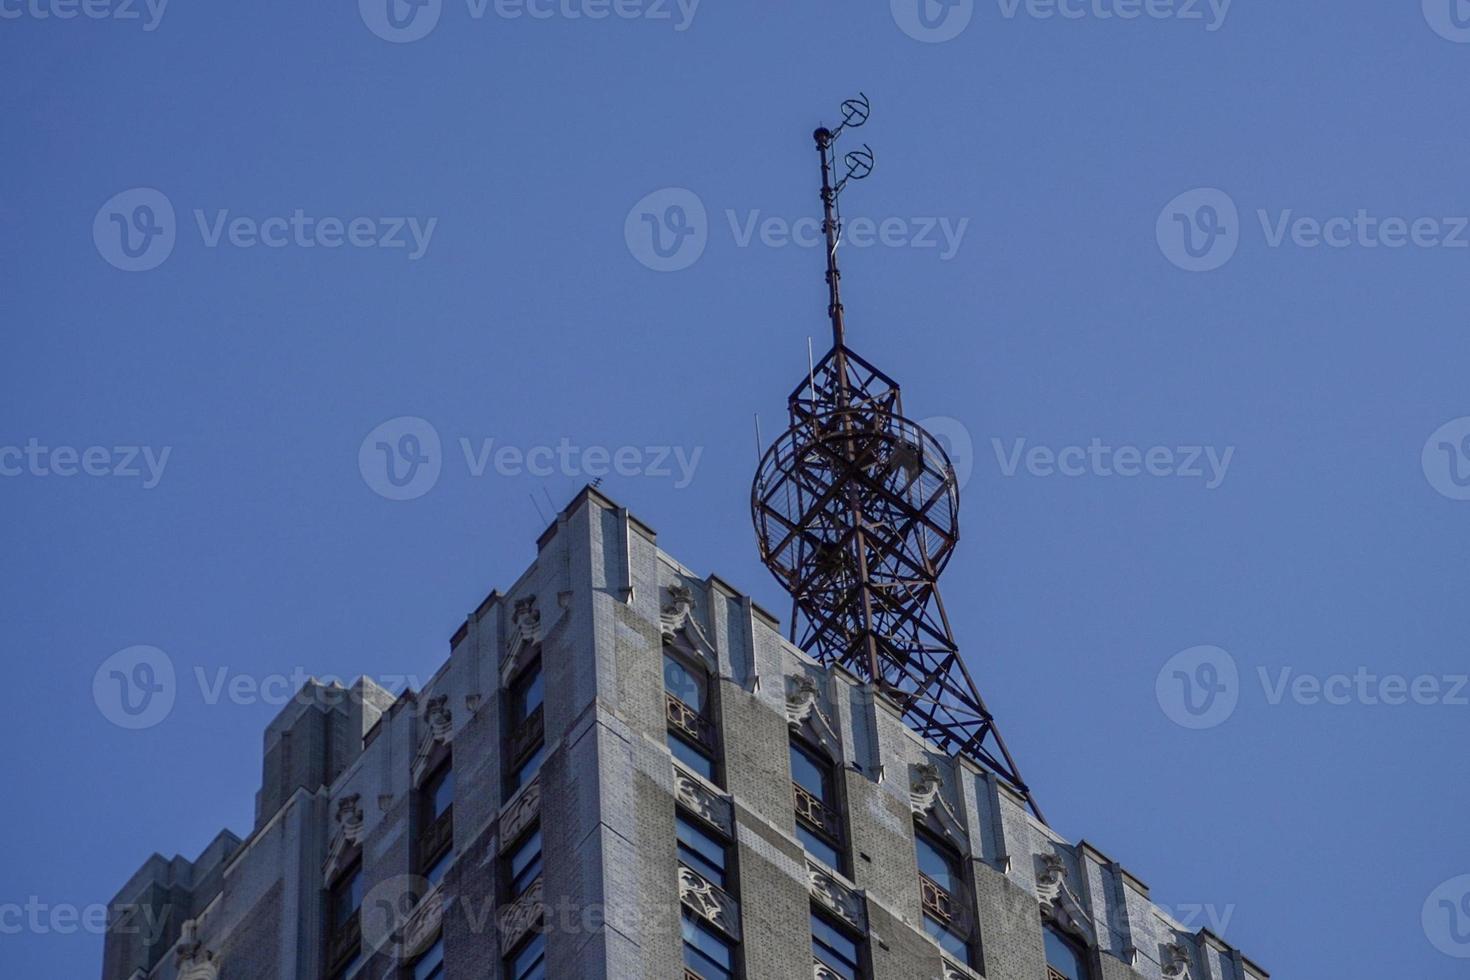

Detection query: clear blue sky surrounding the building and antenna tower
xmin=0 ymin=0 xmax=1470 ymax=980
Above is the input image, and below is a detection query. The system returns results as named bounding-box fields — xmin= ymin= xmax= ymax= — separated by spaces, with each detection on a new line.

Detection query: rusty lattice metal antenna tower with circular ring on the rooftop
xmin=751 ymin=94 xmax=1045 ymax=820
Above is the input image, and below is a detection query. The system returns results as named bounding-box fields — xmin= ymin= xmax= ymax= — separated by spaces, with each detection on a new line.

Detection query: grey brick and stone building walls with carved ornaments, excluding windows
xmin=103 ymin=489 xmax=1267 ymax=980
